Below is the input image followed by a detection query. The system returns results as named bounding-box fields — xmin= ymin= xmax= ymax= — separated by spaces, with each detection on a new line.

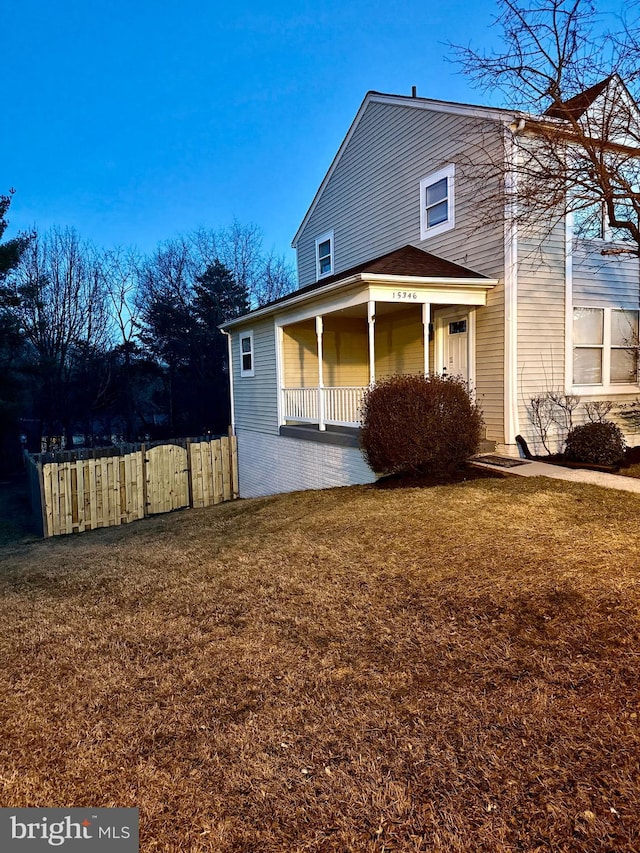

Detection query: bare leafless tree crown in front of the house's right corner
xmin=453 ymin=0 xmax=640 ymax=255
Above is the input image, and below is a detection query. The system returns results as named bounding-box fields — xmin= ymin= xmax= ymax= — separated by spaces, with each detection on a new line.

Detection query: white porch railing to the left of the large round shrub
xmin=282 ymin=385 xmax=367 ymax=428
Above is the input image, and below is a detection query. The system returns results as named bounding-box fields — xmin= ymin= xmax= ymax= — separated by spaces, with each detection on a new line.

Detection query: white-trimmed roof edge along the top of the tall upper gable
xmin=291 ymin=91 xmax=523 ymax=249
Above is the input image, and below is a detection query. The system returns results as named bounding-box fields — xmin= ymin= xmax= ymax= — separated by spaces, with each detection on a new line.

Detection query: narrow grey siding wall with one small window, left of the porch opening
xmin=231 ymin=318 xmax=279 ymax=434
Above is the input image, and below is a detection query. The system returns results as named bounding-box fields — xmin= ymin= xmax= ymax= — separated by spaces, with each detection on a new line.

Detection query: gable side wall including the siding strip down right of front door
xmin=297 ymin=101 xmax=504 ymax=441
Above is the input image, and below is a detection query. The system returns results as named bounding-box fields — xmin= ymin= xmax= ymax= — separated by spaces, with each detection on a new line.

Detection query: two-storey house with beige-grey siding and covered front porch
xmin=222 ymin=87 xmax=640 ymax=497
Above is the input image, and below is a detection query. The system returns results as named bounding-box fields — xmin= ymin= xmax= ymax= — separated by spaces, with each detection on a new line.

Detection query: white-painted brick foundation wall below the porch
xmin=238 ymin=430 xmax=375 ymax=498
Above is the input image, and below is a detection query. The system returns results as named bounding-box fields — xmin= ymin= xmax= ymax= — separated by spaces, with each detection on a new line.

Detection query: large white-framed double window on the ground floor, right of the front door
xmin=573 ymin=308 xmax=638 ymax=386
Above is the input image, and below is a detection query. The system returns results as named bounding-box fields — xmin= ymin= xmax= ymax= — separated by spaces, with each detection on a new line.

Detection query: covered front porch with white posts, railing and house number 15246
xmin=276 ymin=277 xmax=494 ymax=431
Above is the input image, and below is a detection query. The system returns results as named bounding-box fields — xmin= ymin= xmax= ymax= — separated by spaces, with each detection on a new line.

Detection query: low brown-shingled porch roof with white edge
xmin=220 ymin=246 xmax=496 ymax=329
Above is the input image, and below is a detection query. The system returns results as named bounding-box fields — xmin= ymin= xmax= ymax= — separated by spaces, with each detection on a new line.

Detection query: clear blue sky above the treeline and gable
xmin=0 ymin=0 xmax=624 ymax=270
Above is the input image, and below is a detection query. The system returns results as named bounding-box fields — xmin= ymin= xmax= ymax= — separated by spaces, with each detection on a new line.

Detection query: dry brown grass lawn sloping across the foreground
xmin=0 ymin=478 xmax=640 ymax=853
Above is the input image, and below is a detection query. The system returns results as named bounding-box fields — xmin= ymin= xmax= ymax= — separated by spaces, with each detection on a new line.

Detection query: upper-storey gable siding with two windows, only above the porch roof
xmin=298 ymin=102 xmax=503 ymax=286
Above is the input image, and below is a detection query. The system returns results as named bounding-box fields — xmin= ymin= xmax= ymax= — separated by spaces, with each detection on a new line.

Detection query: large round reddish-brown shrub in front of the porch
xmin=361 ymin=374 xmax=483 ymax=477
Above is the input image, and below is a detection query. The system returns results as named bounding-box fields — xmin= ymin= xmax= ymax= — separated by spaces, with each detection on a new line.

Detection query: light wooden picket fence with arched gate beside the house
xmin=26 ymin=435 xmax=238 ymax=537
